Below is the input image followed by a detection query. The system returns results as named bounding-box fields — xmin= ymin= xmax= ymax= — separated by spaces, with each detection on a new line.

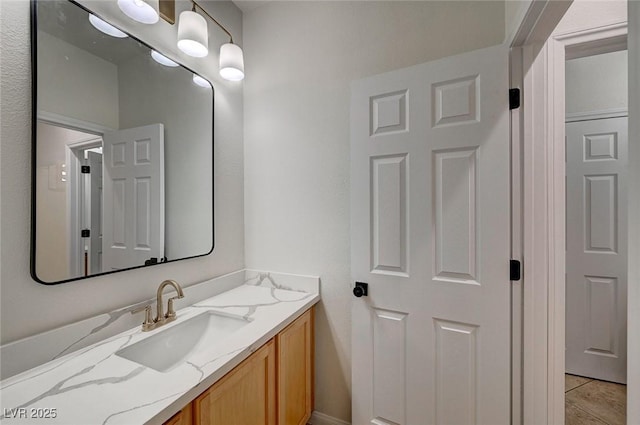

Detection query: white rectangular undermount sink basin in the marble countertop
xmin=116 ymin=312 xmax=249 ymax=372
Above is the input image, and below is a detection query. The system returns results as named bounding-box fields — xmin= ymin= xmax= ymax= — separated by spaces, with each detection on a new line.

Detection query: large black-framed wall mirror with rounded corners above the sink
xmin=31 ymin=0 xmax=214 ymax=284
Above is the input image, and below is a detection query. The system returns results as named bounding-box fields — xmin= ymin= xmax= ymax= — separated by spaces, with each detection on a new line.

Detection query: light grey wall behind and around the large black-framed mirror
xmin=0 ymin=0 xmax=244 ymax=343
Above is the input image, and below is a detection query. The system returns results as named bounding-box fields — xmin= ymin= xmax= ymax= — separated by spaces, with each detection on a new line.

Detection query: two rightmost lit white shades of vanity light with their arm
xmin=178 ymin=0 xmax=244 ymax=81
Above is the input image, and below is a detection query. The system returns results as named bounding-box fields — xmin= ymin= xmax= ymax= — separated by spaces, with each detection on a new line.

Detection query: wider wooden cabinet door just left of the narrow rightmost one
xmin=193 ymin=340 xmax=276 ymax=425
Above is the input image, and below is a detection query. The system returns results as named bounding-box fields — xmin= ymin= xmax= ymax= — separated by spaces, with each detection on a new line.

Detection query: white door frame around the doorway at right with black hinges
xmin=511 ymin=1 xmax=640 ymax=424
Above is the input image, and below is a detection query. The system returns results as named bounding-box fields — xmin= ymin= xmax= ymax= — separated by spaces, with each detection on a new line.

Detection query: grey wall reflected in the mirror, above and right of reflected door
xmin=118 ymin=55 xmax=212 ymax=260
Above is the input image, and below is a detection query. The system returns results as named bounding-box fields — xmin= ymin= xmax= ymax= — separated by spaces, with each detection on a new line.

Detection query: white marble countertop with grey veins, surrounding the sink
xmin=0 ymin=279 xmax=320 ymax=425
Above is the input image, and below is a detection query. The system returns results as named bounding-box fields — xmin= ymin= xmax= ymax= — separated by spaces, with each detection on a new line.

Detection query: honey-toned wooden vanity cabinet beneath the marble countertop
xmin=164 ymin=308 xmax=313 ymax=425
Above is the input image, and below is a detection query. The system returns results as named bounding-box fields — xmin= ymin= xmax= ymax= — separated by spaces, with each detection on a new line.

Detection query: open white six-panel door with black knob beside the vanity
xmin=351 ymin=46 xmax=510 ymax=425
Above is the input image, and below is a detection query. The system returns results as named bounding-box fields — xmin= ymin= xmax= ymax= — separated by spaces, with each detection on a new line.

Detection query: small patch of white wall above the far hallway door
xmin=565 ymin=50 xmax=628 ymax=114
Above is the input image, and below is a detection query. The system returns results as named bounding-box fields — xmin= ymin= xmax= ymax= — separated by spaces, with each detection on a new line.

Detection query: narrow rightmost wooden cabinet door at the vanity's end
xmin=276 ymin=309 xmax=313 ymax=425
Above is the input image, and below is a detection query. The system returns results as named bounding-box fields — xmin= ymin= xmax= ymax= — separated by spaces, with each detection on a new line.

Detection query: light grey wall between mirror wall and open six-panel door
xmin=244 ymin=1 xmax=505 ymax=421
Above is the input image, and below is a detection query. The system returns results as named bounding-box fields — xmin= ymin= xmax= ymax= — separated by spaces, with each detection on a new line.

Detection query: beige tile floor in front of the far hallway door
xmin=564 ymin=374 xmax=627 ymax=425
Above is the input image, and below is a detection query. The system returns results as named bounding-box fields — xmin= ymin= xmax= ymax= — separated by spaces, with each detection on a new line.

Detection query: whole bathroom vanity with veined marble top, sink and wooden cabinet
xmin=0 ymin=271 xmax=320 ymax=425
